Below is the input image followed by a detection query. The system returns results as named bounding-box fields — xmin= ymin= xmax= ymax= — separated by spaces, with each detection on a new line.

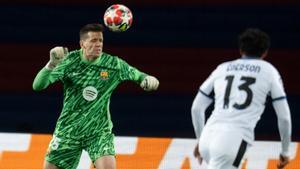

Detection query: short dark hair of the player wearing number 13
xmin=239 ymin=28 xmax=270 ymax=57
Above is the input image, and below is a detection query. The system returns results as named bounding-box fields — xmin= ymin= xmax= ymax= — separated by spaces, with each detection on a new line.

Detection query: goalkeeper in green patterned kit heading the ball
xmin=33 ymin=24 xmax=159 ymax=169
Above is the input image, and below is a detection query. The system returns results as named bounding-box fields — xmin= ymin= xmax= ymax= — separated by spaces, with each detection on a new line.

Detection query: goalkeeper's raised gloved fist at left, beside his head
xmin=46 ymin=46 xmax=68 ymax=69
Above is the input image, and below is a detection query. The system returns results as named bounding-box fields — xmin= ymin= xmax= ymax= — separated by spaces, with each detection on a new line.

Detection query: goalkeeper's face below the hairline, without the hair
xmin=80 ymin=32 xmax=103 ymax=60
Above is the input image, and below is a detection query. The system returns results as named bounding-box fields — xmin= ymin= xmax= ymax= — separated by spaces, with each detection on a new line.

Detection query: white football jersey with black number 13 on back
xmin=200 ymin=57 xmax=286 ymax=143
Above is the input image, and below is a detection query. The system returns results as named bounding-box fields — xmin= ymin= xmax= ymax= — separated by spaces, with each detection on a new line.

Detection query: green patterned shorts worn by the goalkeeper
xmin=46 ymin=132 xmax=115 ymax=169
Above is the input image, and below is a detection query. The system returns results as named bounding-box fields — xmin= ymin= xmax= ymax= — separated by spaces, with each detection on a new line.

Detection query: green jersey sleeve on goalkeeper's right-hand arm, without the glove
xmin=118 ymin=58 xmax=147 ymax=84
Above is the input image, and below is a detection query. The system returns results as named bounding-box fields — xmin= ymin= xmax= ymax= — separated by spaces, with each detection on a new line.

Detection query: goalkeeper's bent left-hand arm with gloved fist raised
xmin=32 ymin=47 xmax=68 ymax=91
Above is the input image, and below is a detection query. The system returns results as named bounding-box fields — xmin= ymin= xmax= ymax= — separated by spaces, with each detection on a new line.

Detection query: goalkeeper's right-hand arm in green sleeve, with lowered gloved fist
xmin=119 ymin=59 xmax=159 ymax=91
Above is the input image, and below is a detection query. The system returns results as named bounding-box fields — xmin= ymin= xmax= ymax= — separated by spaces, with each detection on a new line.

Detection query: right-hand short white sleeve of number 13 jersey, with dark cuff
xmin=270 ymin=68 xmax=286 ymax=100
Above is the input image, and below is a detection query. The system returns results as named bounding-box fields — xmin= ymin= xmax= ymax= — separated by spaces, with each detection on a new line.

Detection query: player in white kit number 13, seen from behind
xmin=192 ymin=29 xmax=291 ymax=169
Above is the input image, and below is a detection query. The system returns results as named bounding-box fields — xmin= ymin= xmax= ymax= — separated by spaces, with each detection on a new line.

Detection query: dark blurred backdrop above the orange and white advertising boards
xmin=0 ymin=0 xmax=300 ymax=141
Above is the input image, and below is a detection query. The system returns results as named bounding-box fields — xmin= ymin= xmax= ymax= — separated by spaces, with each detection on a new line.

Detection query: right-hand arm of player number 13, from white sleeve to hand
xmin=271 ymin=68 xmax=292 ymax=168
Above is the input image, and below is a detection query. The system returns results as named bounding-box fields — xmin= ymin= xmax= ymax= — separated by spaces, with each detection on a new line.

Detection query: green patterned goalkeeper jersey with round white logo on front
xmin=33 ymin=50 xmax=146 ymax=139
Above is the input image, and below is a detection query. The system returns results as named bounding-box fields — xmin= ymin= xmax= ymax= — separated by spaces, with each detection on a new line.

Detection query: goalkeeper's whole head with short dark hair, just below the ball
xmin=79 ymin=23 xmax=104 ymax=61
